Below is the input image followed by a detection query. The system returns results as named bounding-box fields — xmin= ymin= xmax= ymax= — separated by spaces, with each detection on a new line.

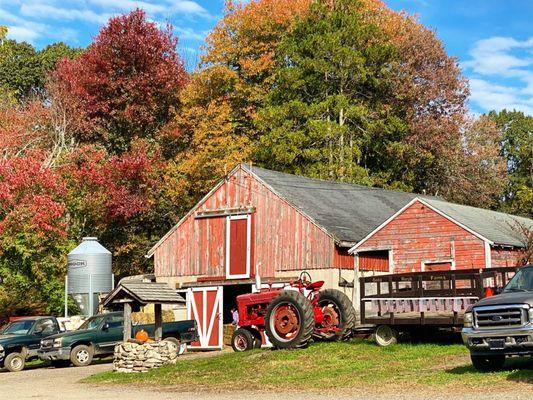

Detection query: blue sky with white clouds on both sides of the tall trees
xmin=0 ymin=0 xmax=533 ymax=114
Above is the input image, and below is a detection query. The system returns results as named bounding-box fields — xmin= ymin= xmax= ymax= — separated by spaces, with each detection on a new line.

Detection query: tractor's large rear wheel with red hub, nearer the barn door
xmin=265 ymin=290 xmax=315 ymax=349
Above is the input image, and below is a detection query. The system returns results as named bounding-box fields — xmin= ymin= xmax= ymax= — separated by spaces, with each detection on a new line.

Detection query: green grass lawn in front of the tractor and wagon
xmin=86 ymin=340 xmax=533 ymax=391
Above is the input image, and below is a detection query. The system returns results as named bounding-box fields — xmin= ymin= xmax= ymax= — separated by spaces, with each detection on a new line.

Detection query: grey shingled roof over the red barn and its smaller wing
xmin=246 ymin=164 xmax=533 ymax=247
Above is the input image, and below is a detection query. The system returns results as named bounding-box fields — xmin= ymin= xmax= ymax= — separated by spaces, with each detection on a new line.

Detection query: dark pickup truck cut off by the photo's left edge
xmin=0 ymin=317 xmax=60 ymax=372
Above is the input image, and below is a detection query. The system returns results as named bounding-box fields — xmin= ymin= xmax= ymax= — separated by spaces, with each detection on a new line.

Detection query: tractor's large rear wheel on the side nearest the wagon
xmin=314 ymin=289 xmax=355 ymax=340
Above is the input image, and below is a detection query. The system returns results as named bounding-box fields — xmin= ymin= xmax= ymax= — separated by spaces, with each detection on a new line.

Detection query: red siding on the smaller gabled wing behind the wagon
xmin=358 ymin=201 xmax=485 ymax=273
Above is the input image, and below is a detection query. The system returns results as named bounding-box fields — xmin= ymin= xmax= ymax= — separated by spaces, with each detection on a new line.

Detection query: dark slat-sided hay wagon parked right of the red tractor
xmin=355 ymin=267 xmax=516 ymax=346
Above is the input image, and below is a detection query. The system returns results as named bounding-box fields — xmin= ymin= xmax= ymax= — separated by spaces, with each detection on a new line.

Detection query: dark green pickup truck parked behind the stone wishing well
xmin=38 ymin=312 xmax=198 ymax=367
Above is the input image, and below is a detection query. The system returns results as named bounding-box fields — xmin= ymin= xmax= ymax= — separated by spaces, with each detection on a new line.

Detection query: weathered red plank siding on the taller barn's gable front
xmin=154 ymin=168 xmax=340 ymax=277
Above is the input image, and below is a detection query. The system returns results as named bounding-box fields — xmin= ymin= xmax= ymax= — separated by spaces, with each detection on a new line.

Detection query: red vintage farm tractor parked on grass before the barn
xmin=231 ymin=271 xmax=355 ymax=351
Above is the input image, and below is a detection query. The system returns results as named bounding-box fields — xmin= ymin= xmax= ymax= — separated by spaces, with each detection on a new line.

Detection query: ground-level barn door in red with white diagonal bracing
xmin=187 ymin=286 xmax=223 ymax=349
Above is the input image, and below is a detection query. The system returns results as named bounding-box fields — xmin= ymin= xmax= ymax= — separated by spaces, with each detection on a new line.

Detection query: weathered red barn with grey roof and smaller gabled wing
xmin=147 ymin=164 xmax=533 ymax=348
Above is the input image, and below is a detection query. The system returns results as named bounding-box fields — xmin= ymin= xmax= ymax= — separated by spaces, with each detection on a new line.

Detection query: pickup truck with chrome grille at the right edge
xmin=462 ymin=265 xmax=533 ymax=371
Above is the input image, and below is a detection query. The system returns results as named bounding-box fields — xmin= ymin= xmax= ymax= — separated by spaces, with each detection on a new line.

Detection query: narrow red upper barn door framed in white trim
xmin=226 ymin=214 xmax=252 ymax=279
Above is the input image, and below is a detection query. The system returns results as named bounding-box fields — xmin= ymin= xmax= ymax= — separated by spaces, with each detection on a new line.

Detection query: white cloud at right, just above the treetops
xmin=462 ymin=36 xmax=533 ymax=114
